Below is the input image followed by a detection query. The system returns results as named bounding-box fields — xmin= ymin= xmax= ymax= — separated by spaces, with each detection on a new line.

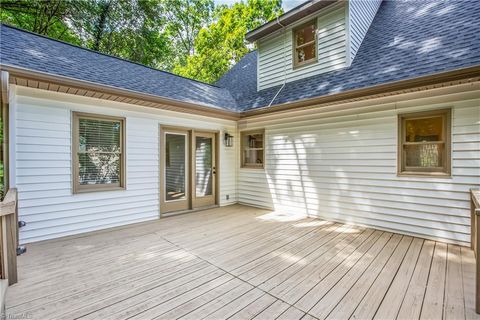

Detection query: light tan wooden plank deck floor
xmin=7 ymin=205 xmax=478 ymax=320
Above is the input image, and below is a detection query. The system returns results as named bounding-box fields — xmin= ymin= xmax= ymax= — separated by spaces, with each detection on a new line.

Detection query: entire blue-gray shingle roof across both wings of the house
xmin=0 ymin=0 xmax=480 ymax=111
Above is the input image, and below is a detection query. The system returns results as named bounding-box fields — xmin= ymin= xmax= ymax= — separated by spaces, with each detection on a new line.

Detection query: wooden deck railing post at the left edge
xmin=0 ymin=189 xmax=18 ymax=285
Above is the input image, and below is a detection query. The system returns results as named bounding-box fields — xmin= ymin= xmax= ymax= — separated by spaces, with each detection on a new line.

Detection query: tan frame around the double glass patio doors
xmin=158 ymin=124 xmax=221 ymax=218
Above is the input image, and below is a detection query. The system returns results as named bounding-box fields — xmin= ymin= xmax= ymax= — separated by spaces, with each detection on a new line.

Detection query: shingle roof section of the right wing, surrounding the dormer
xmin=217 ymin=0 xmax=480 ymax=110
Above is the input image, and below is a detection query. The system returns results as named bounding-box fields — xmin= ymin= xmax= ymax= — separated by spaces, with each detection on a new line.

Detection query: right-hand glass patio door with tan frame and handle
xmin=192 ymin=132 xmax=217 ymax=208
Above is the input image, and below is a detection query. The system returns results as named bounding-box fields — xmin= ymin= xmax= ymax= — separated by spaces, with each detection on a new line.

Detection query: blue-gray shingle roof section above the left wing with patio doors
xmin=0 ymin=25 xmax=236 ymax=110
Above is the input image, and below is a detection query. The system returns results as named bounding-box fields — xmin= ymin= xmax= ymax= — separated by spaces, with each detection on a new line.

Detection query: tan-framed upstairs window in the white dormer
xmin=293 ymin=20 xmax=317 ymax=68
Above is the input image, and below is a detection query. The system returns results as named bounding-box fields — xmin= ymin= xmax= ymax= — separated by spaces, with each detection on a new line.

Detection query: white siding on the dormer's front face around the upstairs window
xmin=258 ymin=5 xmax=346 ymax=90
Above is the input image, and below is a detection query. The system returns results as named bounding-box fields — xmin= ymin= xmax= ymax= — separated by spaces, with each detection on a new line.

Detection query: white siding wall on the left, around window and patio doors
xmin=11 ymin=86 xmax=237 ymax=243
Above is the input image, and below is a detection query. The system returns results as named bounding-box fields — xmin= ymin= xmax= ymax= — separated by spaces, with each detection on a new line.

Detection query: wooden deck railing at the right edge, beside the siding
xmin=470 ymin=189 xmax=480 ymax=313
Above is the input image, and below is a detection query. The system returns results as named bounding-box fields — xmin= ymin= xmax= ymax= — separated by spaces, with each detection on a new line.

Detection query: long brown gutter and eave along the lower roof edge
xmin=0 ymin=64 xmax=480 ymax=121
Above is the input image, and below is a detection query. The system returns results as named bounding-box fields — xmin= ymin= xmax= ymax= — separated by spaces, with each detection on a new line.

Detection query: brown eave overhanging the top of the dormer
xmin=245 ymin=0 xmax=344 ymax=42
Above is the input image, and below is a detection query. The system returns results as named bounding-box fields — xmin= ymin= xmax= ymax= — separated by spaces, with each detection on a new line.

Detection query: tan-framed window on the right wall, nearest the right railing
xmin=398 ymin=109 xmax=451 ymax=175
